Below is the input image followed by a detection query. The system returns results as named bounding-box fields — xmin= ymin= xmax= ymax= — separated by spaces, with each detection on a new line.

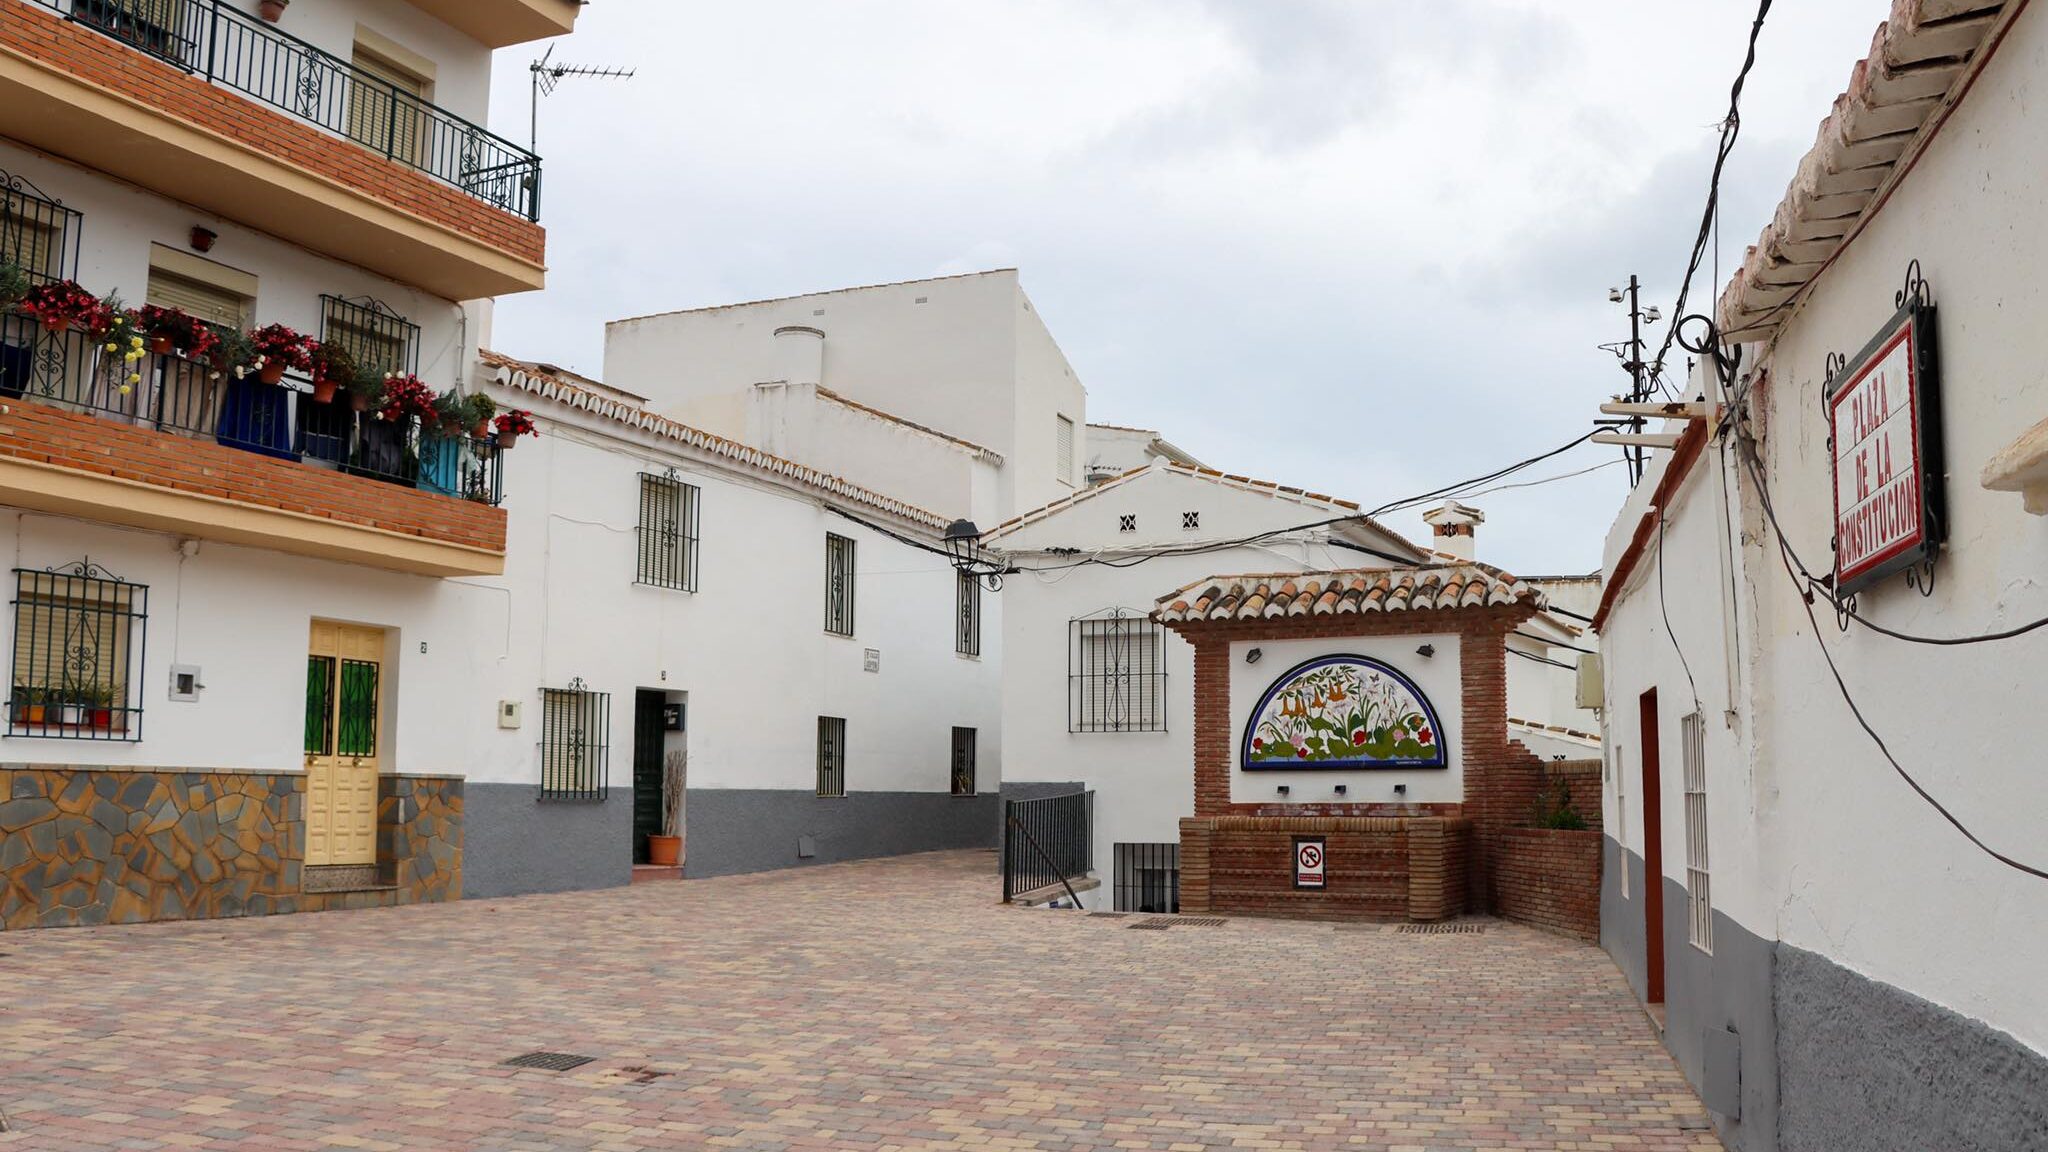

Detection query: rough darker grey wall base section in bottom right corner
xmin=1778 ymin=943 xmax=2048 ymax=1152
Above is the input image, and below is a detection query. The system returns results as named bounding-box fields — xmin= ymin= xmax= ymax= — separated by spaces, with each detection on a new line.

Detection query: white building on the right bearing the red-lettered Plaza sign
xmin=1597 ymin=0 xmax=2048 ymax=1150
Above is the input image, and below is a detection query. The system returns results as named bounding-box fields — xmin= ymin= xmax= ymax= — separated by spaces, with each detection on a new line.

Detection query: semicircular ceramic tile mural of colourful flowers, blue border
xmin=1241 ymin=656 xmax=1448 ymax=771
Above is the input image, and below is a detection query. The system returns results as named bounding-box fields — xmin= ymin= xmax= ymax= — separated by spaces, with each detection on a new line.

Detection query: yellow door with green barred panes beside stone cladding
xmin=305 ymin=621 xmax=385 ymax=865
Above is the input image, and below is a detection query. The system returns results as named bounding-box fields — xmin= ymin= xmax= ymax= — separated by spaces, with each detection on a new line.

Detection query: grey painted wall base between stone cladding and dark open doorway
xmin=463 ymin=783 xmax=633 ymax=900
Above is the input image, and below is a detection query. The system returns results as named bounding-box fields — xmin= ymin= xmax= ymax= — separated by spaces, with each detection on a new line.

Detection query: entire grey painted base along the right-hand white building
xmin=1599 ymin=838 xmax=2048 ymax=1152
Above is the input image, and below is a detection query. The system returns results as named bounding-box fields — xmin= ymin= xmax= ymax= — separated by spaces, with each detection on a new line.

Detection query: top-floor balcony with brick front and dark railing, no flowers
xmin=0 ymin=0 xmax=545 ymax=299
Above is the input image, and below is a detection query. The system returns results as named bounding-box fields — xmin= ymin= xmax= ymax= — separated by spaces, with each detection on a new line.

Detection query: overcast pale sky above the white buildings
xmin=494 ymin=0 xmax=1888 ymax=574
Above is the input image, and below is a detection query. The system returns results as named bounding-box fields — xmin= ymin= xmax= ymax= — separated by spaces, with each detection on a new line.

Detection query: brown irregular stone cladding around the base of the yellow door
xmin=0 ymin=765 xmax=463 ymax=929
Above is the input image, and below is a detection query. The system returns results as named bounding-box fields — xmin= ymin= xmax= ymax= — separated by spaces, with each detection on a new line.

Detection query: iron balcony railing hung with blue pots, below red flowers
xmin=0 ymin=314 xmax=504 ymax=504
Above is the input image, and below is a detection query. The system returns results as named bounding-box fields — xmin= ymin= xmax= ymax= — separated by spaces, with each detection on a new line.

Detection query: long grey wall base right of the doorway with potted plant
xmin=684 ymin=787 xmax=1001 ymax=877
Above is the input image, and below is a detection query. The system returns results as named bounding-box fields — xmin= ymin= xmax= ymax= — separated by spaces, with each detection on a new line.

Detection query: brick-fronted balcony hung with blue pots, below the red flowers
xmin=0 ymin=314 xmax=506 ymax=576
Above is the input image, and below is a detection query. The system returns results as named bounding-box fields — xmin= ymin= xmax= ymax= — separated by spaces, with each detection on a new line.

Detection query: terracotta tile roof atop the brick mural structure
xmin=1153 ymin=562 xmax=1544 ymax=623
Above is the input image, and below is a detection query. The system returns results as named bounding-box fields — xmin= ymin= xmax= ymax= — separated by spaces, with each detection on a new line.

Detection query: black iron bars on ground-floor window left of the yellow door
xmin=6 ymin=560 xmax=150 ymax=744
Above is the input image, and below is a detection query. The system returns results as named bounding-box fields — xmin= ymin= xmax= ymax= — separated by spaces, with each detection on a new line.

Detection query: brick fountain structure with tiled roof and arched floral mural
xmin=1153 ymin=562 xmax=1542 ymax=920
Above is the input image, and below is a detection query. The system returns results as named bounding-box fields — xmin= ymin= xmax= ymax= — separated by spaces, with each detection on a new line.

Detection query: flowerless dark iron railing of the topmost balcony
xmin=31 ymin=0 xmax=541 ymax=219
